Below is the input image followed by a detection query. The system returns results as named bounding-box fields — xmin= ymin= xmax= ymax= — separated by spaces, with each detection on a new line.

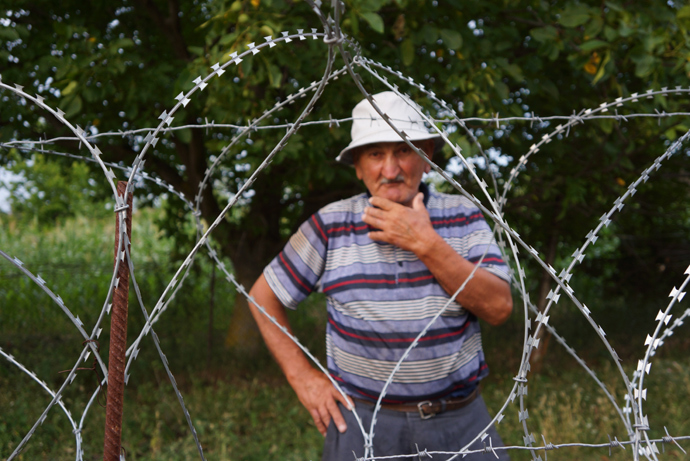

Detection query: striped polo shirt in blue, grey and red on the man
xmin=264 ymin=184 xmax=508 ymax=403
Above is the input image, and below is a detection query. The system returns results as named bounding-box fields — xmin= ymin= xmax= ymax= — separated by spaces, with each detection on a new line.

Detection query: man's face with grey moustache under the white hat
xmin=354 ymin=140 xmax=434 ymax=206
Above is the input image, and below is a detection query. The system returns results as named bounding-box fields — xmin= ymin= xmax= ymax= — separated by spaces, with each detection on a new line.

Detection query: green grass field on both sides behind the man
xmin=0 ymin=210 xmax=690 ymax=460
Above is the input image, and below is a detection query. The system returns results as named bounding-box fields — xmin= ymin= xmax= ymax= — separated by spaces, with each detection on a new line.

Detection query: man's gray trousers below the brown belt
xmin=321 ymin=396 xmax=510 ymax=461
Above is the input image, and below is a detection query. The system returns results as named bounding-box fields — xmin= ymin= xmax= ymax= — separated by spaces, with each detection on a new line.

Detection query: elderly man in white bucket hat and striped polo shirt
xmin=250 ymin=92 xmax=512 ymax=461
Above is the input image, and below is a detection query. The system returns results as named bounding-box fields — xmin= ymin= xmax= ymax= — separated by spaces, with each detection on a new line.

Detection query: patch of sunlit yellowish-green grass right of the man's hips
xmin=484 ymin=358 xmax=690 ymax=460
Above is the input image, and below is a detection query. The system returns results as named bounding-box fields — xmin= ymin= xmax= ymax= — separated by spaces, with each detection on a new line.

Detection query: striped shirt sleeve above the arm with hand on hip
xmin=264 ymin=213 xmax=328 ymax=309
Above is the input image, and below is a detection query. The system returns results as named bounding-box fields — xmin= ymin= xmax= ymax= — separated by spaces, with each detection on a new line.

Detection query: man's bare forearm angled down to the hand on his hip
xmin=249 ymin=275 xmax=313 ymax=388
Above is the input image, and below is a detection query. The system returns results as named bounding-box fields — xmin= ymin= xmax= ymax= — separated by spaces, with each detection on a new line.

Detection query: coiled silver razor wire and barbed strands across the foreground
xmin=0 ymin=1 xmax=690 ymax=460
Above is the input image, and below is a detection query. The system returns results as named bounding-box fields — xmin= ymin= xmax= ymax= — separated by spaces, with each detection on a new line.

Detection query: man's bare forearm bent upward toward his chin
xmin=415 ymin=230 xmax=513 ymax=325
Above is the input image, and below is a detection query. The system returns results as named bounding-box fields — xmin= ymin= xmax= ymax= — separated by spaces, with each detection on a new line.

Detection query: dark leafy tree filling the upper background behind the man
xmin=0 ymin=0 xmax=690 ymax=358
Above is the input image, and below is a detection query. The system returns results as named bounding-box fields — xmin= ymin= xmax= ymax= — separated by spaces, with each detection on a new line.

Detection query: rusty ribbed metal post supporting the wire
xmin=103 ymin=181 xmax=132 ymax=461
